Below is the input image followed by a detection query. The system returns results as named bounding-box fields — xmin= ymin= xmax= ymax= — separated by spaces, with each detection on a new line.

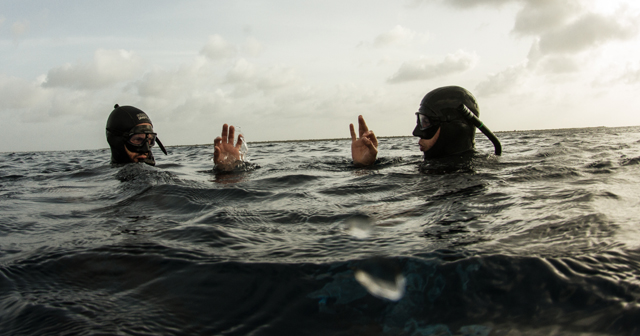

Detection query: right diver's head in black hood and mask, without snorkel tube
xmin=413 ymin=86 xmax=480 ymax=159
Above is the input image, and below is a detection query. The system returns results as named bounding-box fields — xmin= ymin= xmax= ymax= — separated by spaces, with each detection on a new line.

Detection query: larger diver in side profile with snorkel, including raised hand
xmin=349 ymin=86 xmax=502 ymax=166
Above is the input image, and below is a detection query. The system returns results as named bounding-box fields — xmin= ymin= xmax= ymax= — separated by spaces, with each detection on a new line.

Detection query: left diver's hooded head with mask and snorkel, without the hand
xmin=106 ymin=104 xmax=167 ymax=166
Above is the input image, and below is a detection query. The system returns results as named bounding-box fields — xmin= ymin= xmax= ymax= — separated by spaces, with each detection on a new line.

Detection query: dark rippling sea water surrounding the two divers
xmin=0 ymin=127 xmax=640 ymax=335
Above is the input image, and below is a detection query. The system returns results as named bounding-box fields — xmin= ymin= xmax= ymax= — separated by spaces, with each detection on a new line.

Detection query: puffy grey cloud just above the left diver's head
xmin=42 ymin=49 xmax=143 ymax=90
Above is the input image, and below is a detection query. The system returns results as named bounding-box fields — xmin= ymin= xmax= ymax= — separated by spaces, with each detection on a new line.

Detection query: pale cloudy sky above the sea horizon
xmin=0 ymin=0 xmax=640 ymax=152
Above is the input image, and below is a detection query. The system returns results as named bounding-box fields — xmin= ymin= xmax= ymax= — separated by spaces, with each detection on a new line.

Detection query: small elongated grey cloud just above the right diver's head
xmin=387 ymin=50 xmax=478 ymax=83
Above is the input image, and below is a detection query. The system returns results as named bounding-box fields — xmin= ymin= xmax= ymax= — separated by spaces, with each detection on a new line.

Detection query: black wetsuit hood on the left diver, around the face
xmin=106 ymin=104 xmax=156 ymax=166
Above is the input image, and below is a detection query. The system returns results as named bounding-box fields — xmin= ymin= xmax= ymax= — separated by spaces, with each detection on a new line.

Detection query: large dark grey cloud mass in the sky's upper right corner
xmin=460 ymin=0 xmax=640 ymax=95
